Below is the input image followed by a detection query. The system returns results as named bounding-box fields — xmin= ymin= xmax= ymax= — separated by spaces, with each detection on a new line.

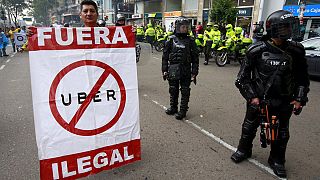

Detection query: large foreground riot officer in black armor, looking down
xmin=231 ymin=10 xmax=310 ymax=177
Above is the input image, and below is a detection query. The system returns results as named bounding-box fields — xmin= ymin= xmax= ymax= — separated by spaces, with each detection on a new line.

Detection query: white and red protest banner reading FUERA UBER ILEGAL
xmin=28 ymin=26 xmax=141 ymax=179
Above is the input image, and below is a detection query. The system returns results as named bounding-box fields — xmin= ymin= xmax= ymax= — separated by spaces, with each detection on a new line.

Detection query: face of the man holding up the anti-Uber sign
xmin=80 ymin=4 xmax=98 ymax=27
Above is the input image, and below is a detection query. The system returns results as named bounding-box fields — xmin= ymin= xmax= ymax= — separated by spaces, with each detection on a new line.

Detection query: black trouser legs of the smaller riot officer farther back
xmin=168 ymin=77 xmax=191 ymax=112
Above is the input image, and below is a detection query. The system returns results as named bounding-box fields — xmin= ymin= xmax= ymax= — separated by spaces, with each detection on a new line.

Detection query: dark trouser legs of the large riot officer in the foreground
xmin=238 ymin=100 xmax=293 ymax=163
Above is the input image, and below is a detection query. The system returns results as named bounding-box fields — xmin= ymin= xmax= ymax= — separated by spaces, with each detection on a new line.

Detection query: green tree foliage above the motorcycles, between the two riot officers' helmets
xmin=209 ymin=0 xmax=238 ymax=27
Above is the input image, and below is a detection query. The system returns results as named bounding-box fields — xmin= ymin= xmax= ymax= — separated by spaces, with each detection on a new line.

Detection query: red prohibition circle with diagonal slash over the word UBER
xmin=49 ymin=60 xmax=126 ymax=136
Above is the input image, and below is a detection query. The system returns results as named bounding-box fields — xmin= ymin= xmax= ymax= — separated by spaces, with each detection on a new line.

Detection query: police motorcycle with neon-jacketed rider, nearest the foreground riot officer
xmin=216 ymin=27 xmax=252 ymax=67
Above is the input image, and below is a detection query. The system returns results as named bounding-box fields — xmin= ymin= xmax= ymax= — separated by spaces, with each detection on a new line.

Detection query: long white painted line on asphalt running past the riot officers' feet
xmin=148 ymin=97 xmax=285 ymax=179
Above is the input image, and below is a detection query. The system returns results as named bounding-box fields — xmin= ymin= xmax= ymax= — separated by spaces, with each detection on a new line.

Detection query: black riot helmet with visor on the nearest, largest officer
xmin=266 ymin=10 xmax=298 ymax=40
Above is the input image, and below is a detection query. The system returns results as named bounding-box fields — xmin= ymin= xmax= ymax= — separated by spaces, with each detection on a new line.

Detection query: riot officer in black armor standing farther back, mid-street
xmin=162 ymin=16 xmax=199 ymax=120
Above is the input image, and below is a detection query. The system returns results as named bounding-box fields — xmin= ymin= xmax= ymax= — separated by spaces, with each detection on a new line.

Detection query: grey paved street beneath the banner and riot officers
xmin=0 ymin=45 xmax=320 ymax=180
